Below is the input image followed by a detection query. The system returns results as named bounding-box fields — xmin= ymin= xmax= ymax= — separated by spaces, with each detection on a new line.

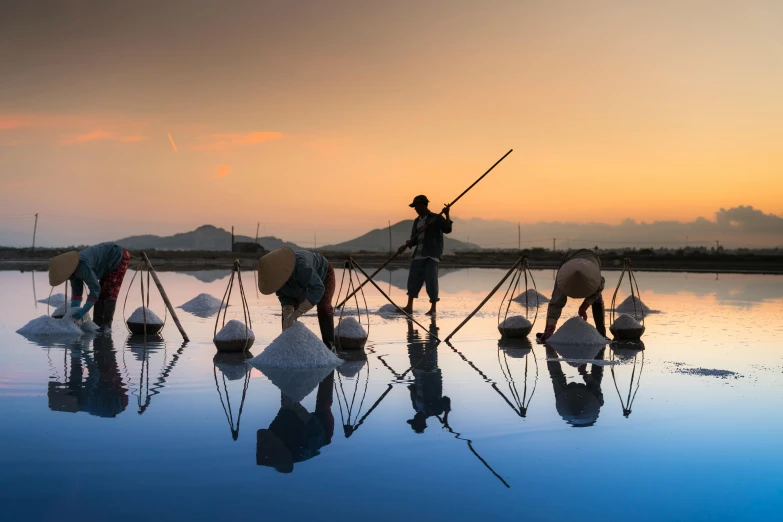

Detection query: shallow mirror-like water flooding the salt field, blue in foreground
xmin=0 ymin=269 xmax=783 ymax=521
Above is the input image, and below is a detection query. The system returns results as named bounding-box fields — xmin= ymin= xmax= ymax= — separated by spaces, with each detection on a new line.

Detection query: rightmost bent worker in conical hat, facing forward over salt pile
xmin=537 ymin=249 xmax=606 ymax=341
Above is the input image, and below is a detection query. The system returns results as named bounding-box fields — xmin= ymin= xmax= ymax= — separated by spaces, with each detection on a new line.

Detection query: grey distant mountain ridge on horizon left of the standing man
xmin=115 ymin=225 xmax=300 ymax=252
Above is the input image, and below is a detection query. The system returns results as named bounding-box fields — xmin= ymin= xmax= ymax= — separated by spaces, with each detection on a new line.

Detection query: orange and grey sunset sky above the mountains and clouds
xmin=0 ymin=0 xmax=783 ymax=244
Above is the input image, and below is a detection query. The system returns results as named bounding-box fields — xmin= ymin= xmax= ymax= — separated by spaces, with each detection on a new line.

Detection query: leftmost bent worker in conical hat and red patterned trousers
xmin=49 ymin=243 xmax=130 ymax=330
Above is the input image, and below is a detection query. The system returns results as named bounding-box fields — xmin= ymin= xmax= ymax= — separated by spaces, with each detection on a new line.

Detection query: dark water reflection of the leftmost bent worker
xmin=47 ymin=335 xmax=128 ymax=417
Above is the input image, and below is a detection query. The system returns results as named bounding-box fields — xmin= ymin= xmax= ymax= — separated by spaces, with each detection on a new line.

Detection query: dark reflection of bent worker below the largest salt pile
xmin=256 ymin=372 xmax=334 ymax=473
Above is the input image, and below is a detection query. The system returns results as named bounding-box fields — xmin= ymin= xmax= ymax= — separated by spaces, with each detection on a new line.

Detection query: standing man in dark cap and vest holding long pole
xmin=397 ymin=195 xmax=453 ymax=315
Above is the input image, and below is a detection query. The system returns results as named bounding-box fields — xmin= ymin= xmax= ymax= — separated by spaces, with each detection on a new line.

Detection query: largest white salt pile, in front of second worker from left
xmin=250 ymin=321 xmax=342 ymax=368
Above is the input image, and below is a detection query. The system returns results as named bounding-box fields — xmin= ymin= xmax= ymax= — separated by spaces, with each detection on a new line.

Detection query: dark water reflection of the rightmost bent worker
xmin=546 ymin=345 xmax=604 ymax=428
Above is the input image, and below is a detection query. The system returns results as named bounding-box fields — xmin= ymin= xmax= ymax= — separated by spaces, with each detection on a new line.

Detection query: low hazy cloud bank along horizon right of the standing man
xmin=454 ymin=206 xmax=783 ymax=249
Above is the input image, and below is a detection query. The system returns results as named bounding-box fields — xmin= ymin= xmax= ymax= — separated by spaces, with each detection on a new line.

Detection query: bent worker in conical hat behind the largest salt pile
xmin=258 ymin=247 xmax=335 ymax=348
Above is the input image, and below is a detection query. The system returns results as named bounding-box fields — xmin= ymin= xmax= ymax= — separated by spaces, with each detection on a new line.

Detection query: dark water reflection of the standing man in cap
xmin=408 ymin=318 xmax=451 ymax=433
